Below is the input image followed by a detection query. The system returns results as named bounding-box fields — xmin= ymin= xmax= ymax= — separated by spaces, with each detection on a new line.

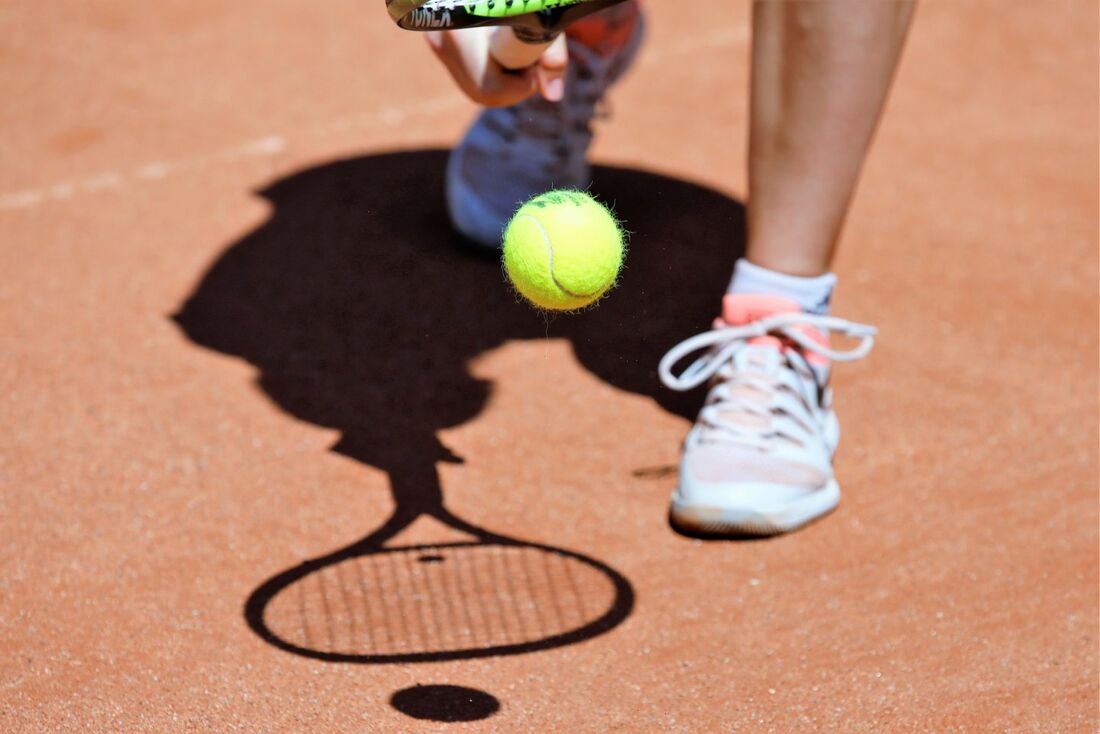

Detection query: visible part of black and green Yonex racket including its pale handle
xmin=386 ymin=0 xmax=623 ymax=69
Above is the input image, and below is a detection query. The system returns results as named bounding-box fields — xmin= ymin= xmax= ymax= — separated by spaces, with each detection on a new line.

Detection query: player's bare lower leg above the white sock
xmin=747 ymin=0 xmax=915 ymax=276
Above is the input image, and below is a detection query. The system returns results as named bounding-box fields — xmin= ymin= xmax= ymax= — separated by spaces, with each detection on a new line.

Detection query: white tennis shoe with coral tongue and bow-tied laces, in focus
xmin=660 ymin=295 xmax=876 ymax=536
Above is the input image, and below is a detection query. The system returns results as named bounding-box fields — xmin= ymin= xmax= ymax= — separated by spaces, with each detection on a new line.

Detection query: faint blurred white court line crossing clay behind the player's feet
xmin=0 ymin=28 xmax=749 ymax=209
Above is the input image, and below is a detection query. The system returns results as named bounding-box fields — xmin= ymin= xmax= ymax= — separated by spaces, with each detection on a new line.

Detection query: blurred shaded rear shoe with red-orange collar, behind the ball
xmin=447 ymin=2 xmax=642 ymax=248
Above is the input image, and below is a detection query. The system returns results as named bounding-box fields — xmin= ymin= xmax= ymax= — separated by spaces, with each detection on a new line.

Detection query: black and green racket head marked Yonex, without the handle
xmin=386 ymin=0 xmax=623 ymax=43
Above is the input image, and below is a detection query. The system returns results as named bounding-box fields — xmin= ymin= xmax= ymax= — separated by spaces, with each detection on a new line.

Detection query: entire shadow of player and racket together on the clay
xmin=174 ymin=150 xmax=745 ymax=662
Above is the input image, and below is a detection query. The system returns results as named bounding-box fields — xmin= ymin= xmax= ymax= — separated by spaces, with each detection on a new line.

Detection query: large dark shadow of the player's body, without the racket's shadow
xmin=174 ymin=150 xmax=745 ymax=661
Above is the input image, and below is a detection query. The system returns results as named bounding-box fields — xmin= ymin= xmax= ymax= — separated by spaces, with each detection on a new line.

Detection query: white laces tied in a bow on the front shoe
xmin=658 ymin=314 xmax=878 ymax=449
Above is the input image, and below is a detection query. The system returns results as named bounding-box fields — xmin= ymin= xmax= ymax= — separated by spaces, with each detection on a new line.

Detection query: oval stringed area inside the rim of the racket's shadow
xmin=265 ymin=544 xmax=616 ymax=656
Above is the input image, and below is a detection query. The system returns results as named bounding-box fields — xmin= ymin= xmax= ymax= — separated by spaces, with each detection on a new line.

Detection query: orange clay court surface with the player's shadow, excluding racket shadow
xmin=0 ymin=0 xmax=1100 ymax=734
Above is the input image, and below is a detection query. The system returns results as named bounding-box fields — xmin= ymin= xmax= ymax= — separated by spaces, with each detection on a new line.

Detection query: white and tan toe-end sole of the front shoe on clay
xmin=669 ymin=480 xmax=840 ymax=537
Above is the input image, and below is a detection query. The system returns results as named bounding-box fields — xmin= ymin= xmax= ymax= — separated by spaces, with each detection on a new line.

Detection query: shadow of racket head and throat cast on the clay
xmin=245 ymin=468 xmax=634 ymax=664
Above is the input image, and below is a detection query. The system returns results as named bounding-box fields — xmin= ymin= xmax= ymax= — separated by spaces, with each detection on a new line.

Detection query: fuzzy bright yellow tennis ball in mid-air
xmin=504 ymin=189 xmax=625 ymax=311
